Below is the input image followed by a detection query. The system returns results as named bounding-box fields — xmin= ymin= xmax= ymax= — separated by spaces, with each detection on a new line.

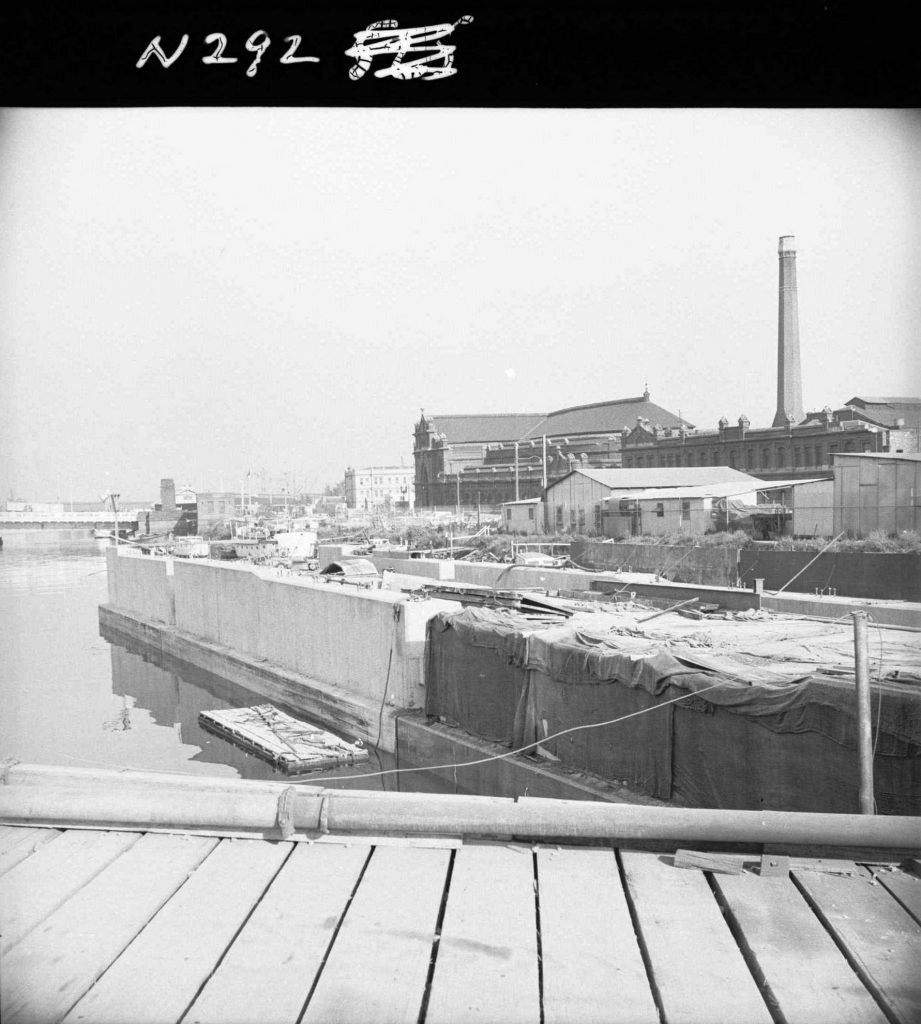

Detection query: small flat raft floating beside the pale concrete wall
xmin=199 ymin=705 xmax=368 ymax=773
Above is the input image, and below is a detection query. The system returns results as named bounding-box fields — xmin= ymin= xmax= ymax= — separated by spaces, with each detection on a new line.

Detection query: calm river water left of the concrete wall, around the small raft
xmin=0 ymin=530 xmax=445 ymax=792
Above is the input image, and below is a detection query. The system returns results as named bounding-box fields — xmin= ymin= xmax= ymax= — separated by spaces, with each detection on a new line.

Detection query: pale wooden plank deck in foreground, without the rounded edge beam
xmin=0 ymin=826 xmax=921 ymax=1024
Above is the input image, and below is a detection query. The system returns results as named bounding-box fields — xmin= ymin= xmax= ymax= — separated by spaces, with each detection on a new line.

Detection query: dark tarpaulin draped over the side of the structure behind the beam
xmin=425 ymin=608 xmax=921 ymax=814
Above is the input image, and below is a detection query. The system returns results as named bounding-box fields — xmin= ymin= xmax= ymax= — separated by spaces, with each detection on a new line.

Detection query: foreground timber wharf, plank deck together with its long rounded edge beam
xmin=0 ymin=765 xmax=921 ymax=1024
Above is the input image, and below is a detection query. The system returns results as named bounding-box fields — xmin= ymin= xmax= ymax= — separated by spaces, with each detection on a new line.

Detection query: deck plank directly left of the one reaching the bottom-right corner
xmin=714 ymin=874 xmax=886 ymax=1024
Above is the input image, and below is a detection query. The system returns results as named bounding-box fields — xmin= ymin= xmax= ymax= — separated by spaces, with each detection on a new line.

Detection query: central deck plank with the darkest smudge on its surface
xmin=425 ymin=846 xmax=540 ymax=1024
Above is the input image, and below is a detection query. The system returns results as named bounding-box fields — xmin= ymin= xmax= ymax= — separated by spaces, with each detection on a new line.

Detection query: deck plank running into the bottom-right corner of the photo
xmin=794 ymin=871 xmax=921 ymax=1024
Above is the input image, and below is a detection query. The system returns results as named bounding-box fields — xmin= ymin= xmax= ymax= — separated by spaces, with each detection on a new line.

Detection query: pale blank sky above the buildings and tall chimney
xmin=0 ymin=108 xmax=921 ymax=501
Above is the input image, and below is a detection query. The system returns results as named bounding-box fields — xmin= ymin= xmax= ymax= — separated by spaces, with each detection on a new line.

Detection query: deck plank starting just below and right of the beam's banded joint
xmin=183 ymin=843 xmax=371 ymax=1024
